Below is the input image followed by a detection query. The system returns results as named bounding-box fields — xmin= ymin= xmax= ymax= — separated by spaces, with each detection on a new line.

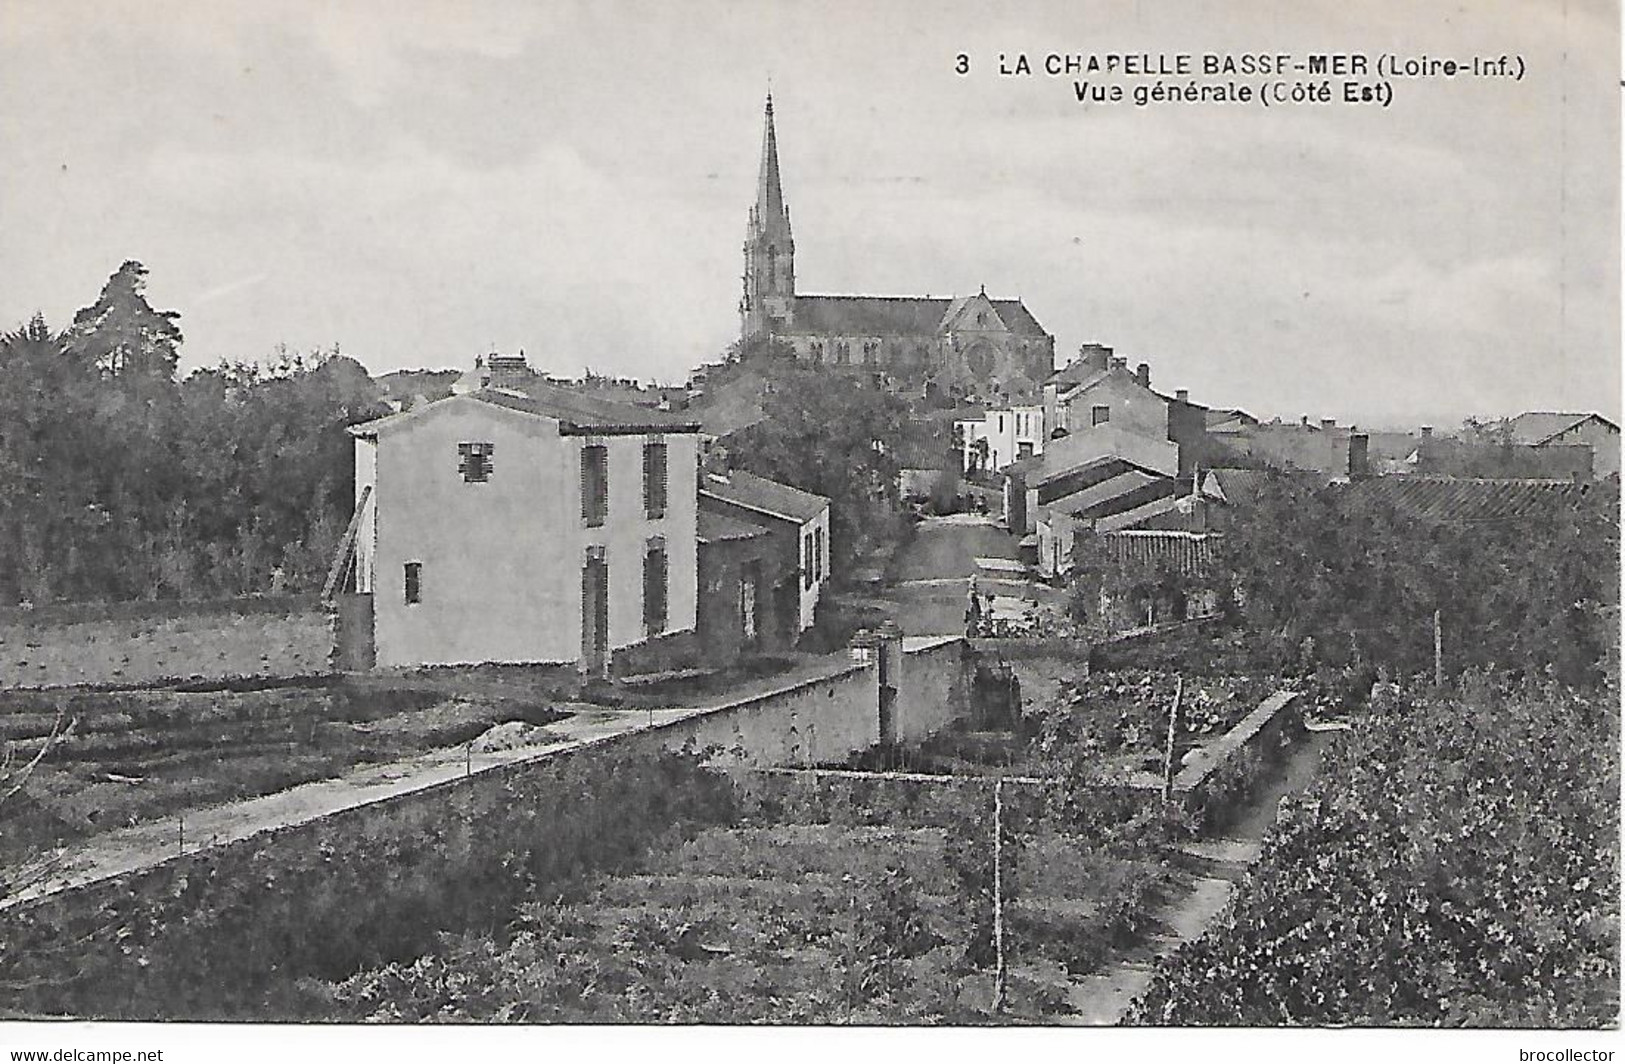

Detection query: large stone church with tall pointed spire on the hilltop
xmin=739 ymin=94 xmax=1055 ymax=406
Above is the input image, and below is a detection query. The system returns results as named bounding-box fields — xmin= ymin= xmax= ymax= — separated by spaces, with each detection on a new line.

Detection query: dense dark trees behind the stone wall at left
xmin=0 ymin=262 xmax=387 ymax=606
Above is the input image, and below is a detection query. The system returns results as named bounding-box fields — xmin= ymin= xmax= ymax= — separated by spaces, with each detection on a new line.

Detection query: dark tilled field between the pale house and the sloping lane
xmin=0 ymin=682 xmax=566 ymax=866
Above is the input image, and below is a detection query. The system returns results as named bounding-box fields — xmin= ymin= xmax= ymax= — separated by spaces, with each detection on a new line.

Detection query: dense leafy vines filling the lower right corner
xmin=1134 ymin=676 xmax=1620 ymax=1027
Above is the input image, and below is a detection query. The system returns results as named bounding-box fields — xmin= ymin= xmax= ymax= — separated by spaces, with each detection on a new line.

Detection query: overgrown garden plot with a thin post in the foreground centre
xmin=327 ymin=783 xmax=1183 ymax=1023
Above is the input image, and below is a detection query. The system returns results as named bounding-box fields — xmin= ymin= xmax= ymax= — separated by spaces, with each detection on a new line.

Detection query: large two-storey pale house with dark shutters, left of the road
xmin=349 ymin=383 xmax=699 ymax=673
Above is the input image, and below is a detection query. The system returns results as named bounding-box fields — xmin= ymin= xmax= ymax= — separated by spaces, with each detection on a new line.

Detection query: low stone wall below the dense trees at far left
xmin=0 ymin=598 xmax=333 ymax=687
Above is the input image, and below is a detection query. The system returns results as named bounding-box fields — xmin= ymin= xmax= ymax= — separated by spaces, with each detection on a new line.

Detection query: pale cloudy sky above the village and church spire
xmin=0 ymin=0 xmax=1620 ymax=427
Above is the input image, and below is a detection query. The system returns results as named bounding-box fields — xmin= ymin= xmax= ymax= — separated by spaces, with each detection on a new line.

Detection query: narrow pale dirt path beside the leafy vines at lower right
xmin=1061 ymin=734 xmax=1326 ymax=1027
